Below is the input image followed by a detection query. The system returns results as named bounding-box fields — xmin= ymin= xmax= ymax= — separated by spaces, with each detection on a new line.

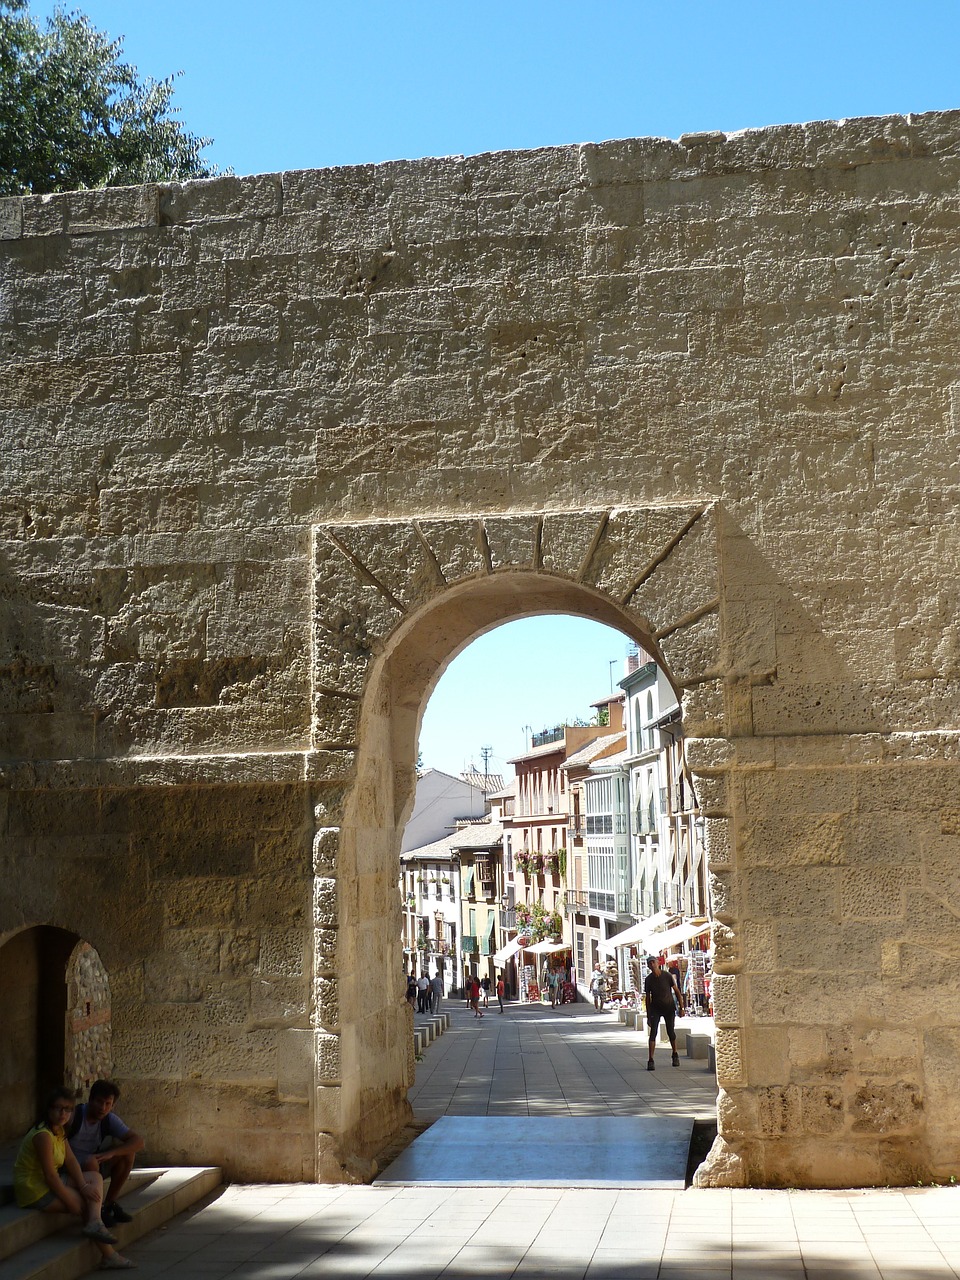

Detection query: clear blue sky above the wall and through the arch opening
xmin=32 ymin=0 xmax=960 ymax=772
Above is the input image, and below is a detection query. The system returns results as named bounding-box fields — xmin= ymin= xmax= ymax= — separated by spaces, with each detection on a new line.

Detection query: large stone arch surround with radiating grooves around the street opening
xmin=312 ymin=502 xmax=741 ymax=1176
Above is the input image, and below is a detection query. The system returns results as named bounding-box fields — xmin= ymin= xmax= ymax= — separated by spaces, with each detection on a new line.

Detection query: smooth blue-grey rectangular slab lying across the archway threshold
xmin=376 ymin=1116 xmax=694 ymax=1189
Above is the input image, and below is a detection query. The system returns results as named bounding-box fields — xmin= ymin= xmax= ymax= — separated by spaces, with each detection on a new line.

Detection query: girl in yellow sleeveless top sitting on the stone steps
xmin=13 ymin=1089 xmax=136 ymax=1271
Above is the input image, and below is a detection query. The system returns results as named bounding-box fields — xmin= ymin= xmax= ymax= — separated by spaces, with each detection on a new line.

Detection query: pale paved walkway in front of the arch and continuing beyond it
xmin=104 ymin=1006 xmax=960 ymax=1280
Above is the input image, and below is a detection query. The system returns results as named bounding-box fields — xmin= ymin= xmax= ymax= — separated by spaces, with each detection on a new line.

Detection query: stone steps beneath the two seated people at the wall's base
xmin=0 ymin=1167 xmax=223 ymax=1280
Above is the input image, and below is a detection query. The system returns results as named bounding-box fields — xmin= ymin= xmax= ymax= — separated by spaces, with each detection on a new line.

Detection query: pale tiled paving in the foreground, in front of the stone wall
xmin=112 ymin=1185 xmax=960 ymax=1280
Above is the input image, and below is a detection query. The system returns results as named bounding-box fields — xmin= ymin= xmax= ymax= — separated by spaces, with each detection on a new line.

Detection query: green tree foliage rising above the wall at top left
xmin=0 ymin=0 xmax=218 ymax=196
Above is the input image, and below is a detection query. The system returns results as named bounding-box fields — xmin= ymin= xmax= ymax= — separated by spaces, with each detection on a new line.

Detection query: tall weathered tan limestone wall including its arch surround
xmin=0 ymin=113 xmax=960 ymax=1185
